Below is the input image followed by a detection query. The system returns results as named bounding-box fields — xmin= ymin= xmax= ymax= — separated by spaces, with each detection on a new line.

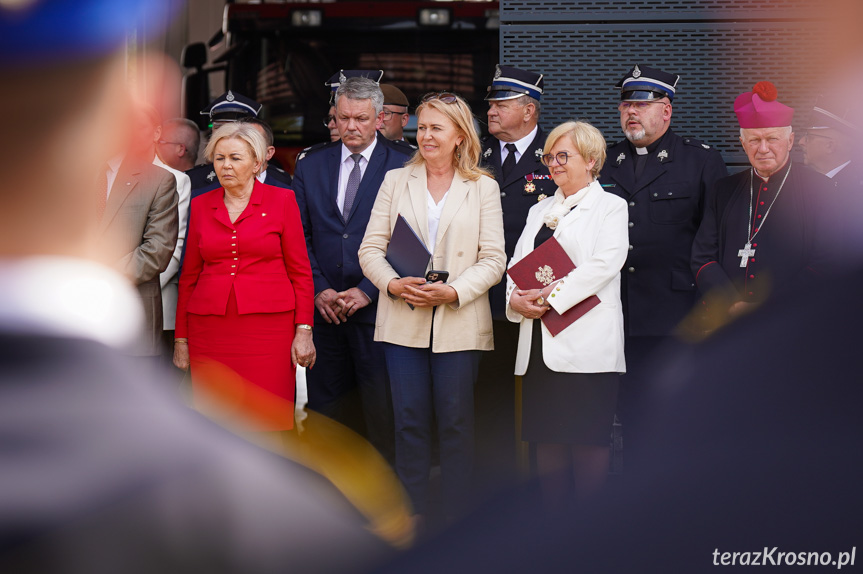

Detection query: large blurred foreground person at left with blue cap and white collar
xmin=0 ymin=0 xmax=385 ymax=574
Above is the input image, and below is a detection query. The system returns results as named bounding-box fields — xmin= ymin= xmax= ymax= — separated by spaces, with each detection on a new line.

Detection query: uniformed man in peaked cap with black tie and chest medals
xmin=475 ymin=66 xmax=557 ymax=491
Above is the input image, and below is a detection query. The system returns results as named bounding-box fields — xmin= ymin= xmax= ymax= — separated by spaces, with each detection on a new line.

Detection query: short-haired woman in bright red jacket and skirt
xmin=174 ymin=123 xmax=315 ymax=431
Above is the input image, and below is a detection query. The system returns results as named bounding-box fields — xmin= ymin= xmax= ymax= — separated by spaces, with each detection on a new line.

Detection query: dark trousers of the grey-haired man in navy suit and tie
xmin=306 ymin=320 xmax=395 ymax=464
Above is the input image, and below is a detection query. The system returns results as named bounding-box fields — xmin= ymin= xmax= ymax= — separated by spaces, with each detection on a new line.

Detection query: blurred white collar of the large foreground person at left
xmin=0 ymin=256 xmax=144 ymax=351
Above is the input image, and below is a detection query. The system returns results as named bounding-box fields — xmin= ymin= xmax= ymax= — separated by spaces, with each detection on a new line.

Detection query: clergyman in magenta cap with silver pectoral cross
xmin=692 ymin=82 xmax=832 ymax=318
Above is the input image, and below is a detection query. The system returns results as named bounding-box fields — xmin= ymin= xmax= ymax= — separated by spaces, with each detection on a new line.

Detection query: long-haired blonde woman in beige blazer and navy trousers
xmin=359 ymin=93 xmax=506 ymax=521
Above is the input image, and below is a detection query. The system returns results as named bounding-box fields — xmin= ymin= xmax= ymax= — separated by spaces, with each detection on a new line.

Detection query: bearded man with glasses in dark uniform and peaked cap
xmin=600 ymin=65 xmax=728 ymax=468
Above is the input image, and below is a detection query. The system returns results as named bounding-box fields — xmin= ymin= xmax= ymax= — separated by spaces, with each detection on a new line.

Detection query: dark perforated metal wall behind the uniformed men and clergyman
xmin=501 ymin=12 xmax=826 ymax=164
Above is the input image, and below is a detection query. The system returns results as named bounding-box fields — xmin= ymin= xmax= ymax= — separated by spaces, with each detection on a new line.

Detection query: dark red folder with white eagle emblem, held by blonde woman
xmin=507 ymin=237 xmax=600 ymax=337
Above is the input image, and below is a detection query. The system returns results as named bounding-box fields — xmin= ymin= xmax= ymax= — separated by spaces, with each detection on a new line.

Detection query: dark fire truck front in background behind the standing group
xmin=183 ymin=0 xmax=499 ymax=171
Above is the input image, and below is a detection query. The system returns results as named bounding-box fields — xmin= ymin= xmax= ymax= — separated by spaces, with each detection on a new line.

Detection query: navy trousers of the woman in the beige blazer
xmin=384 ymin=343 xmax=481 ymax=517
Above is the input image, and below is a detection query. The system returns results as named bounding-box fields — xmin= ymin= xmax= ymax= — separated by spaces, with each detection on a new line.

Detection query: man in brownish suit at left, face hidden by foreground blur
xmin=97 ymin=144 xmax=179 ymax=357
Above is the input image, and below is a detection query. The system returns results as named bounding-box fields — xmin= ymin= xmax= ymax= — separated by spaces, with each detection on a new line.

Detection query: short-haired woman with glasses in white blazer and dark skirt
xmin=506 ymin=122 xmax=629 ymax=497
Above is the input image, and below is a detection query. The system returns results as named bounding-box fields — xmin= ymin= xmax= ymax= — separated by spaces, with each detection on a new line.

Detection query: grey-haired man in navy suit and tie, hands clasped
xmin=294 ymin=77 xmax=412 ymax=461
